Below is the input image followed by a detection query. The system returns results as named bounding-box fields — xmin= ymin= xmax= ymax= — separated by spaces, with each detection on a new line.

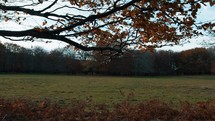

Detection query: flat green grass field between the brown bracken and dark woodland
xmin=0 ymin=74 xmax=215 ymax=104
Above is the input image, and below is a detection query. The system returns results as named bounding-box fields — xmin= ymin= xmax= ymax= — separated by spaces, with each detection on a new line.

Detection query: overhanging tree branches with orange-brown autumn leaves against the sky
xmin=0 ymin=0 xmax=215 ymax=55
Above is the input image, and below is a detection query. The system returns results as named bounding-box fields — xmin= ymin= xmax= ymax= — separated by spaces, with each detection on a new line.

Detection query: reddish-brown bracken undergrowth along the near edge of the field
xmin=0 ymin=99 xmax=215 ymax=121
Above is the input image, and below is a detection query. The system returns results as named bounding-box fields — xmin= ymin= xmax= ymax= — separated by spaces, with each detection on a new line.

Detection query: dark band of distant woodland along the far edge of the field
xmin=0 ymin=43 xmax=215 ymax=76
